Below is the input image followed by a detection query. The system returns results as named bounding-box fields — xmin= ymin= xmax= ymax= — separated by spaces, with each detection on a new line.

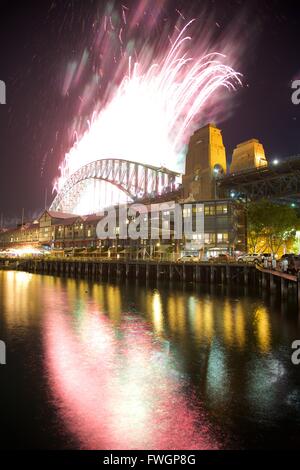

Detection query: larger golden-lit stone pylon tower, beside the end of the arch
xmin=182 ymin=124 xmax=226 ymax=201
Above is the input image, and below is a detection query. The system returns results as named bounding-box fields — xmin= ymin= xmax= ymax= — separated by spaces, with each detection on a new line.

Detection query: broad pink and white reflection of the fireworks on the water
xmin=44 ymin=294 xmax=217 ymax=449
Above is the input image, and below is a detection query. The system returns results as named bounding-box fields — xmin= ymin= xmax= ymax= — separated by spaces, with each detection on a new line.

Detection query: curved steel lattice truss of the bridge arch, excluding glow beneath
xmin=50 ymin=158 xmax=179 ymax=212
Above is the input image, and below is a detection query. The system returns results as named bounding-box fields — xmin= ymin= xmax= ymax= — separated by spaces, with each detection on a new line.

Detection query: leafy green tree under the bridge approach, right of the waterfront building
xmin=247 ymin=199 xmax=299 ymax=255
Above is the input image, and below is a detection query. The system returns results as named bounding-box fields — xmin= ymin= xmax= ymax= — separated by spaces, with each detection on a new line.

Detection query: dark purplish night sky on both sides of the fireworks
xmin=0 ymin=0 xmax=300 ymax=222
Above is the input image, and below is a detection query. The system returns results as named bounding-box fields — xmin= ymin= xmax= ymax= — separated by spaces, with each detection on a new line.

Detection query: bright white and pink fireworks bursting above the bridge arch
xmin=54 ymin=1 xmax=241 ymax=212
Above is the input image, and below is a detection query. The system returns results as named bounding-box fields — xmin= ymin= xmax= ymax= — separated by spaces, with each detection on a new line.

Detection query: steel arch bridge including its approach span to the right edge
xmin=50 ymin=125 xmax=300 ymax=215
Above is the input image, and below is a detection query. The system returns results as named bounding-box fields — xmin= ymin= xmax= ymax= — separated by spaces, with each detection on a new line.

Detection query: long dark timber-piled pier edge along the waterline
xmin=0 ymin=258 xmax=300 ymax=305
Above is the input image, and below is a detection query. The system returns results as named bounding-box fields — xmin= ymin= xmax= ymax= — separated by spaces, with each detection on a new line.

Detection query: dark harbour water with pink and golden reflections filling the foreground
xmin=0 ymin=271 xmax=300 ymax=449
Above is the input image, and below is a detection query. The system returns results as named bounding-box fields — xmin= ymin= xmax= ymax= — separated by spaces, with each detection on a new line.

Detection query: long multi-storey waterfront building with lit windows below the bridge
xmin=0 ymin=199 xmax=246 ymax=258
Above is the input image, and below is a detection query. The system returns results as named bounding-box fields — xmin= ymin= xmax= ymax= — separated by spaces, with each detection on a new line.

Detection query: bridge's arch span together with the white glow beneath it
xmin=50 ymin=158 xmax=180 ymax=214
